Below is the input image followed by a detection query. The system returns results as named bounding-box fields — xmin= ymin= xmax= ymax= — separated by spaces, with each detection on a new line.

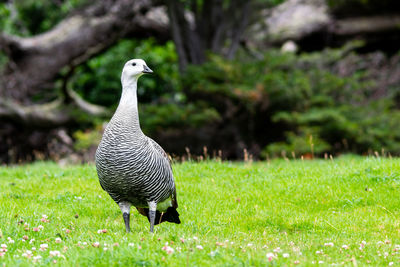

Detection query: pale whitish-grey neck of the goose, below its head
xmin=115 ymin=79 xmax=140 ymax=130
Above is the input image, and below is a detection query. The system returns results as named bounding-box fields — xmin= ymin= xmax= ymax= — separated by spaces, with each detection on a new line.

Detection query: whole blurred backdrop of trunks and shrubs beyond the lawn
xmin=0 ymin=0 xmax=400 ymax=164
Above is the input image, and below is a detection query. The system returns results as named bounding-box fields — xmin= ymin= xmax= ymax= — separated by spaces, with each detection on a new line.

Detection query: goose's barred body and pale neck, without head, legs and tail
xmin=96 ymin=64 xmax=177 ymax=216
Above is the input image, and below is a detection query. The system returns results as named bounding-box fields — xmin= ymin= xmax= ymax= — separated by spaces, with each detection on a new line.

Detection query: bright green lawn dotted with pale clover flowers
xmin=0 ymin=156 xmax=400 ymax=266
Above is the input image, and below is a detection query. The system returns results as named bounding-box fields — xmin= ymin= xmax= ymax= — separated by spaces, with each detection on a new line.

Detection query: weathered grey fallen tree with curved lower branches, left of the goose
xmin=0 ymin=0 xmax=170 ymax=163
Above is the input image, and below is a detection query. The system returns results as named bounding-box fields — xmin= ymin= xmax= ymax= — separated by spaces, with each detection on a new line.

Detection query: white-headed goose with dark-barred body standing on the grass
xmin=95 ymin=59 xmax=181 ymax=233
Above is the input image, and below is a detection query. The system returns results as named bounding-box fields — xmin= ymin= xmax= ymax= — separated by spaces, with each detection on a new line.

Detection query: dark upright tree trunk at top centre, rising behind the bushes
xmin=167 ymin=0 xmax=253 ymax=71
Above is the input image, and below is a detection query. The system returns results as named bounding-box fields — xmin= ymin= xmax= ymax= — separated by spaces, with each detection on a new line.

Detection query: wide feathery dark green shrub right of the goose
xmin=182 ymin=44 xmax=400 ymax=155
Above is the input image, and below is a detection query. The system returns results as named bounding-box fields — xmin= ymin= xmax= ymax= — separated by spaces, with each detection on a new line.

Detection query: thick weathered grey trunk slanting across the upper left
xmin=0 ymin=0 xmax=169 ymax=118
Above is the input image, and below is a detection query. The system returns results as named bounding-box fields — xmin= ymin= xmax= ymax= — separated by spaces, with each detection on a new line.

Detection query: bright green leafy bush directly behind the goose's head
xmin=70 ymin=39 xmax=178 ymax=107
